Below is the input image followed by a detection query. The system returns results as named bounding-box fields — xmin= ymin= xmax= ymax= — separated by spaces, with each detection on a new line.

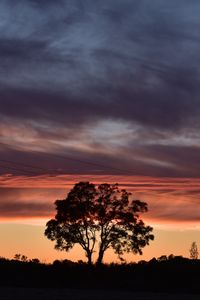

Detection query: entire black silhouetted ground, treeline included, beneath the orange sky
xmin=0 ymin=257 xmax=200 ymax=300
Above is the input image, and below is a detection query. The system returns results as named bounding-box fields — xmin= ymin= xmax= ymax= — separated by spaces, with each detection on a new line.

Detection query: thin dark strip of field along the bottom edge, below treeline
xmin=0 ymin=287 xmax=199 ymax=300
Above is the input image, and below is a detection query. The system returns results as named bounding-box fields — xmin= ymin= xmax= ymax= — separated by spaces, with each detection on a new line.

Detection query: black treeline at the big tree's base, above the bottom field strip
xmin=0 ymin=255 xmax=200 ymax=294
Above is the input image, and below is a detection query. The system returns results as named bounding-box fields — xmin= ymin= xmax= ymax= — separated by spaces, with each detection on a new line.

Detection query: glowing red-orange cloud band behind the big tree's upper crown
xmin=0 ymin=175 xmax=200 ymax=227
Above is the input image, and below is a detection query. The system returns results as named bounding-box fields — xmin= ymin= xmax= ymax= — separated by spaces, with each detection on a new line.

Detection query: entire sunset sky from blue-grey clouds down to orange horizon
xmin=0 ymin=0 xmax=200 ymax=261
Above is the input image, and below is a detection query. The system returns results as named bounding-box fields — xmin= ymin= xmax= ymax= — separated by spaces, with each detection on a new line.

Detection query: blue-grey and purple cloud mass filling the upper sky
xmin=0 ymin=0 xmax=200 ymax=130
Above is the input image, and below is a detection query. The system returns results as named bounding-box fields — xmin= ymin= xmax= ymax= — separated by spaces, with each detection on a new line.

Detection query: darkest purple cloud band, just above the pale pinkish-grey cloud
xmin=0 ymin=82 xmax=200 ymax=130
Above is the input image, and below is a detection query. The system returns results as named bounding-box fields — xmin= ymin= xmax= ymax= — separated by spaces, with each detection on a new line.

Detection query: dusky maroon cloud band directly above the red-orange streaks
xmin=0 ymin=137 xmax=200 ymax=178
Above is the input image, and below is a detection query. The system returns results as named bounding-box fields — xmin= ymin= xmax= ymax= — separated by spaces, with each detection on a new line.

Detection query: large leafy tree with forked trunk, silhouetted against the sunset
xmin=45 ymin=182 xmax=154 ymax=264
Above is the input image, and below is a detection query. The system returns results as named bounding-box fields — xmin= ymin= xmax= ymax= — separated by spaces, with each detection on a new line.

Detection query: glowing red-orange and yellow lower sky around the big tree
xmin=0 ymin=174 xmax=200 ymax=262
